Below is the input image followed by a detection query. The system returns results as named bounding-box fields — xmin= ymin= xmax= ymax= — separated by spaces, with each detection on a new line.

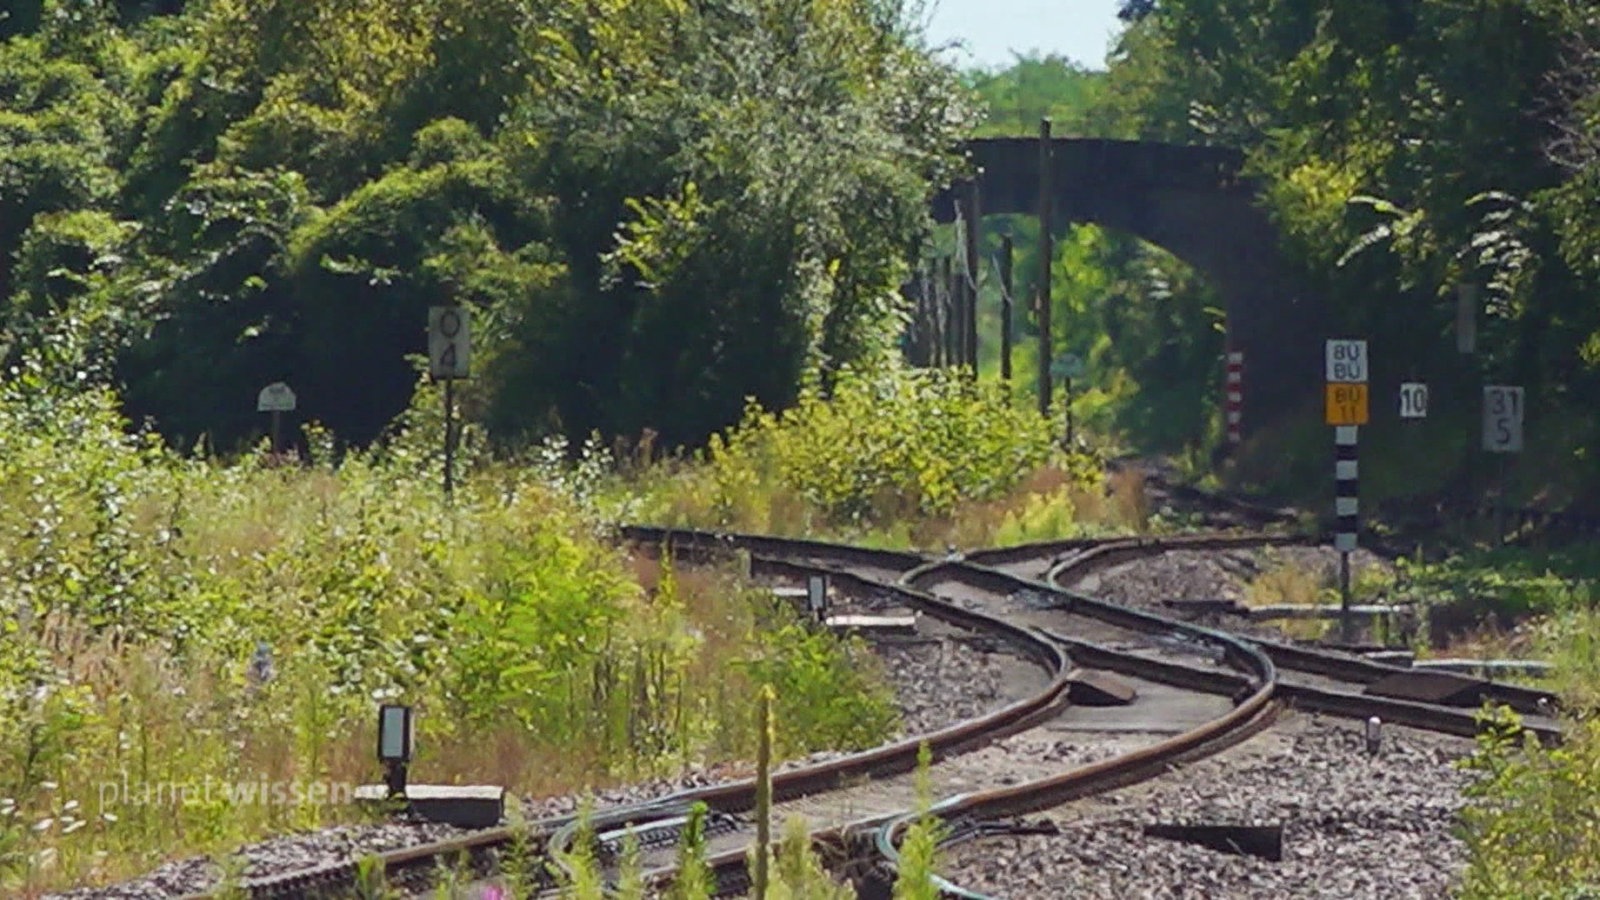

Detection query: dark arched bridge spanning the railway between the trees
xmin=933 ymin=138 xmax=1328 ymax=437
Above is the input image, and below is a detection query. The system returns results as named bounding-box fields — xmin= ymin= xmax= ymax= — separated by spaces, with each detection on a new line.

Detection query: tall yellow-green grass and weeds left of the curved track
xmin=0 ymin=371 xmax=894 ymax=897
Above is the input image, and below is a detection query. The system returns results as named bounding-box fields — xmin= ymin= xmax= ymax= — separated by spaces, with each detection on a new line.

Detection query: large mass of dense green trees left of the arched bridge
xmin=0 ymin=0 xmax=966 ymax=445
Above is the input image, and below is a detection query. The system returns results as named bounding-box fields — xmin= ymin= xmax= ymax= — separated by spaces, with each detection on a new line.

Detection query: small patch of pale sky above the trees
xmin=926 ymin=0 xmax=1120 ymax=69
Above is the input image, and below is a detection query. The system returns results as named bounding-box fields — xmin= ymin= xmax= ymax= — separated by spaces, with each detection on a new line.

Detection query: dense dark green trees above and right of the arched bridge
xmin=1106 ymin=0 xmax=1600 ymax=501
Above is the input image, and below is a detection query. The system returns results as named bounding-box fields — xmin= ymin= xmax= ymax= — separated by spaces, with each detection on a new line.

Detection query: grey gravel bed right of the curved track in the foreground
xmin=941 ymin=717 xmax=1472 ymax=900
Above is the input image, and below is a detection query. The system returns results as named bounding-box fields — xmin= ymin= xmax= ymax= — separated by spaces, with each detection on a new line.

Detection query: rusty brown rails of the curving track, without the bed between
xmin=202 ymin=527 xmax=1552 ymax=898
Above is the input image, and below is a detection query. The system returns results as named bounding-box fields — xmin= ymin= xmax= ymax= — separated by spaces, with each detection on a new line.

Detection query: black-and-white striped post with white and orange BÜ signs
xmin=1325 ymin=340 xmax=1368 ymax=644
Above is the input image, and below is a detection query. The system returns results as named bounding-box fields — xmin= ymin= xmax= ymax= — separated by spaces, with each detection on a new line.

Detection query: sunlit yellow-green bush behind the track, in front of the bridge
xmin=640 ymin=360 xmax=1098 ymax=543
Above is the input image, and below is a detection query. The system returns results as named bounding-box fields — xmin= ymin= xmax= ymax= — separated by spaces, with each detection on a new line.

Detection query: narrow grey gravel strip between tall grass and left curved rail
xmin=51 ymin=598 xmax=1008 ymax=900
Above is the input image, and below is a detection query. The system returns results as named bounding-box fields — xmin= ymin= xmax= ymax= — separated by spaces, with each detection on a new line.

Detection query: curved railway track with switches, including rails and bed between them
xmin=178 ymin=516 xmax=1558 ymax=898
